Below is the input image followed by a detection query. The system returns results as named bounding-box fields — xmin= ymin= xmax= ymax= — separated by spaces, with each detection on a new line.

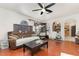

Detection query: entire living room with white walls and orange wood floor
xmin=0 ymin=3 xmax=79 ymax=56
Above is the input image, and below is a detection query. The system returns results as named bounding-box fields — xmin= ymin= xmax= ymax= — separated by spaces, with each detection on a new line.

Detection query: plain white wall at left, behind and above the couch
xmin=0 ymin=8 xmax=33 ymax=49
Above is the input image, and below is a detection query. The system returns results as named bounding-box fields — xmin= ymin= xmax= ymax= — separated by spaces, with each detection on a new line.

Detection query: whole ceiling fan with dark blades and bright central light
xmin=32 ymin=3 xmax=55 ymax=15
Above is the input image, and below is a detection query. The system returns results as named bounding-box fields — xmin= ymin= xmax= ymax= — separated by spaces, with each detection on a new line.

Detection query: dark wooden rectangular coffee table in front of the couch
xmin=23 ymin=39 xmax=48 ymax=56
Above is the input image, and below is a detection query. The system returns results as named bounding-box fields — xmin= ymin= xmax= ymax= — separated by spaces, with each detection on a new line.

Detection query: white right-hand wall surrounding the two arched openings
xmin=47 ymin=14 xmax=79 ymax=41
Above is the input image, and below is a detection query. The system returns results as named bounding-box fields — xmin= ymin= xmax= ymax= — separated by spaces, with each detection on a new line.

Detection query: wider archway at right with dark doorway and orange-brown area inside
xmin=64 ymin=19 xmax=76 ymax=40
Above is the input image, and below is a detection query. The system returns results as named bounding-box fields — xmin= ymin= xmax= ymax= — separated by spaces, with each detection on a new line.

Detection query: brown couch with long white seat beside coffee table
xmin=8 ymin=32 xmax=40 ymax=49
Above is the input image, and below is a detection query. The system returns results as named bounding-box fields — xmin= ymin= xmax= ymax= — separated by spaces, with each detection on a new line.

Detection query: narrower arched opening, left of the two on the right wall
xmin=52 ymin=20 xmax=62 ymax=40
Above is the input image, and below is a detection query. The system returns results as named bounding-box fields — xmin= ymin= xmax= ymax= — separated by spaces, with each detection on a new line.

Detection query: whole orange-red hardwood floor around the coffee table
xmin=0 ymin=40 xmax=79 ymax=56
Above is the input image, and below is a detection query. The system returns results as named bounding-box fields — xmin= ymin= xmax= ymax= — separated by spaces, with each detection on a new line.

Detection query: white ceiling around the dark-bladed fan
xmin=0 ymin=3 xmax=79 ymax=20
